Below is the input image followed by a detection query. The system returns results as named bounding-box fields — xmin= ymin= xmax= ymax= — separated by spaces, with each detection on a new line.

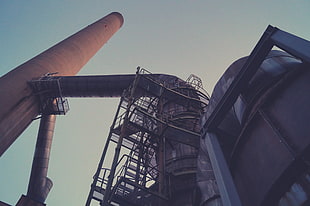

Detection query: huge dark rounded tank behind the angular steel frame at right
xmin=201 ymin=51 xmax=310 ymax=206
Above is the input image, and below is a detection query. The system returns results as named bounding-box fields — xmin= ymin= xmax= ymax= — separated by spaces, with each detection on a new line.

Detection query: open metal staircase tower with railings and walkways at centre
xmin=86 ymin=70 xmax=206 ymax=206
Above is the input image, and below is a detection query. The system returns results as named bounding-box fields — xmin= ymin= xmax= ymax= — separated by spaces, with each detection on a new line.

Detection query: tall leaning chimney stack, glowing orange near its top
xmin=0 ymin=12 xmax=123 ymax=156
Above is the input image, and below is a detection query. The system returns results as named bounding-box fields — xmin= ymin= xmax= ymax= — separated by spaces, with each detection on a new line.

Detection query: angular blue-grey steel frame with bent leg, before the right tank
xmin=202 ymin=25 xmax=310 ymax=206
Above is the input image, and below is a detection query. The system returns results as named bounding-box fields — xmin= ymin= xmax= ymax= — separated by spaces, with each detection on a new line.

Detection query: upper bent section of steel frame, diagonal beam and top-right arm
xmin=204 ymin=25 xmax=310 ymax=134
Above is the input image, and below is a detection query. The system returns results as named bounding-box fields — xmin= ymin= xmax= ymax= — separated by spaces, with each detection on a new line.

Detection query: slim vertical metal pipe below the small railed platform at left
xmin=27 ymin=115 xmax=56 ymax=203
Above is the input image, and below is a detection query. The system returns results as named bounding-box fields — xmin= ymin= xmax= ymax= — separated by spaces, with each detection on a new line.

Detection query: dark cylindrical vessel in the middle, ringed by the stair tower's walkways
xmin=159 ymin=75 xmax=203 ymax=205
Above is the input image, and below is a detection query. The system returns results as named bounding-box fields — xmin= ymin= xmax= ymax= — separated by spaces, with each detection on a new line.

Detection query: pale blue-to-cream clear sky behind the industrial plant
xmin=0 ymin=0 xmax=310 ymax=206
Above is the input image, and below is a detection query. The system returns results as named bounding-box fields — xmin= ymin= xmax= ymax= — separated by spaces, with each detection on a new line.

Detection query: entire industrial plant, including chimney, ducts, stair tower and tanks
xmin=0 ymin=13 xmax=310 ymax=206
